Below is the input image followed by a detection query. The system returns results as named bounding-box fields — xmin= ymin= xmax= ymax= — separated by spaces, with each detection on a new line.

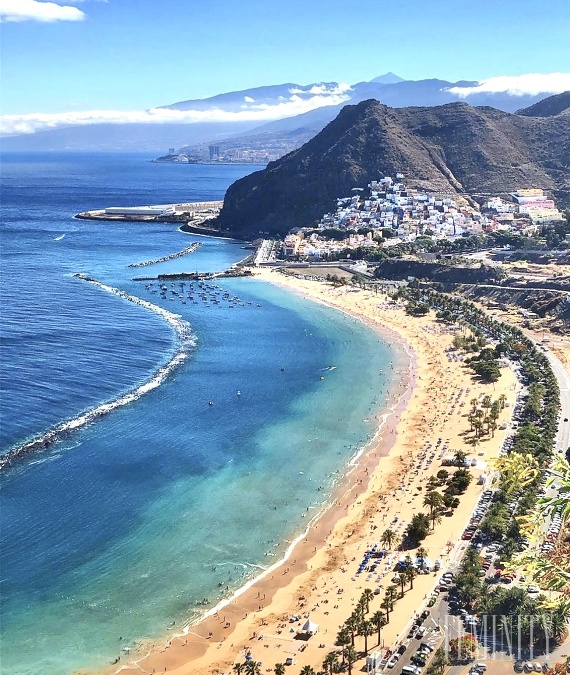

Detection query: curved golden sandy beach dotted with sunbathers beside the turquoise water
xmin=100 ymin=269 xmax=517 ymax=675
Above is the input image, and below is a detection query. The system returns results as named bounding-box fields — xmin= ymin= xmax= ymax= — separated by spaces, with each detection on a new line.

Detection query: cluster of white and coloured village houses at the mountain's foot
xmin=282 ymin=173 xmax=564 ymax=260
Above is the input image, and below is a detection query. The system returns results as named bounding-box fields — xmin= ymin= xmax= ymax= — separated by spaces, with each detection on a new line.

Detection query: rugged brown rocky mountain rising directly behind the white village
xmin=214 ymin=100 xmax=570 ymax=236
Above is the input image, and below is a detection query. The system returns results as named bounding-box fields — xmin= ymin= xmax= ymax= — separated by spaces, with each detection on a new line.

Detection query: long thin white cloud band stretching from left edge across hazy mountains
xmin=0 ymin=94 xmax=349 ymax=134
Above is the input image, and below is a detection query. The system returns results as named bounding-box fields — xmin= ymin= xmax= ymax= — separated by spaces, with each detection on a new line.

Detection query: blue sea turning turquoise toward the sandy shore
xmin=0 ymin=153 xmax=397 ymax=675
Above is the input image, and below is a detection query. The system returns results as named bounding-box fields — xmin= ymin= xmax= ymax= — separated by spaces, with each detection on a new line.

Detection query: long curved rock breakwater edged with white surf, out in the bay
xmin=0 ymin=274 xmax=196 ymax=472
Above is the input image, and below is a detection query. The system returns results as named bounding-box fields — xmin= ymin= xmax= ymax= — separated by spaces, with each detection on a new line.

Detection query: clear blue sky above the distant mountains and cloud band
xmin=0 ymin=0 xmax=570 ymax=133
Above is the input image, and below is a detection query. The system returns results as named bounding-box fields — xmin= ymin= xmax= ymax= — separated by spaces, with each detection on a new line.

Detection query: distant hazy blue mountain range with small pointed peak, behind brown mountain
xmin=2 ymin=73 xmax=560 ymax=152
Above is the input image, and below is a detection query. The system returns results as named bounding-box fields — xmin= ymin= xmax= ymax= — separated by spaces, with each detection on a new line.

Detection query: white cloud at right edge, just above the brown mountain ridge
xmin=447 ymin=73 xmax=570 ymax=98
